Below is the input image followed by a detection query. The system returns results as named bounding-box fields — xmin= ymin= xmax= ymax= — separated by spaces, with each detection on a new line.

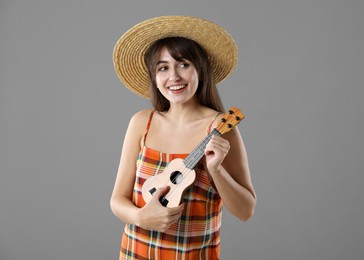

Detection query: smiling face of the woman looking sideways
xmin=156 ymin=47 xmax=198 ymax=104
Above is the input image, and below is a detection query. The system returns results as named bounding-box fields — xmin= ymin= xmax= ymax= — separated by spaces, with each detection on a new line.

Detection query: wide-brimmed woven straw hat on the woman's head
xmin=113 ymin=16 xmax=238 ymax=98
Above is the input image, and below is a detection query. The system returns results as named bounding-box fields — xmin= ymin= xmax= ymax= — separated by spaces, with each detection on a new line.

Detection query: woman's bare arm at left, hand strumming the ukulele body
xmin=110 ymin=110 xmax=183 ymax=231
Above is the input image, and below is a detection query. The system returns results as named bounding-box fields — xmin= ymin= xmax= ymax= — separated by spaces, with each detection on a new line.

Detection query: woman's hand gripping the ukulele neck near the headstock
xmin=205 ymin=136 xmax=230 ymax=173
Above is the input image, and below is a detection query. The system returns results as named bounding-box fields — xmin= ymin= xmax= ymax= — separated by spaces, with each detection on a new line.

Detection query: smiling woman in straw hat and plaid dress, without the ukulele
xmin=110 ymin=16 xmax=256 ymax=259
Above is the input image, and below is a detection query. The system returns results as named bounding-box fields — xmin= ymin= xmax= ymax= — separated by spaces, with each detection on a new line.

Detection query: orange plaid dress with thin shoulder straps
xmin=120 ymin=112 xmax=222 ymax=260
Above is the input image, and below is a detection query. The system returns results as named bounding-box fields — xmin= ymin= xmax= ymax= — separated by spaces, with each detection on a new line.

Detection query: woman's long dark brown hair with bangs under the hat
xmin=144 ymin=37 xmax=224 ymax=112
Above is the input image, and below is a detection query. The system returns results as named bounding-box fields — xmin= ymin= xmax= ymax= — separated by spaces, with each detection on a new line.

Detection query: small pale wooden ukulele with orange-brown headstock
xmin=142 ymin=107 xmax=244 ymax=208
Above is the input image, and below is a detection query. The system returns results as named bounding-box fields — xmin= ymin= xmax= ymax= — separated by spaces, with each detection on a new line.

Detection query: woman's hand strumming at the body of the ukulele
xmin=138 ymin=186 xmax=184 ymax=232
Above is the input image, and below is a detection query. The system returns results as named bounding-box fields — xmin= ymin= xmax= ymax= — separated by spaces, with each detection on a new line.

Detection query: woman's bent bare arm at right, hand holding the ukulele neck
xmin=205 ymin=128 xmax=256 ymax=221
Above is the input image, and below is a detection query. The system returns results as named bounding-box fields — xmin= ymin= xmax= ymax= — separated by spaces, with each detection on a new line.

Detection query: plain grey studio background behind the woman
xmin=0 ymin=0 xmax=364 ymax=260
